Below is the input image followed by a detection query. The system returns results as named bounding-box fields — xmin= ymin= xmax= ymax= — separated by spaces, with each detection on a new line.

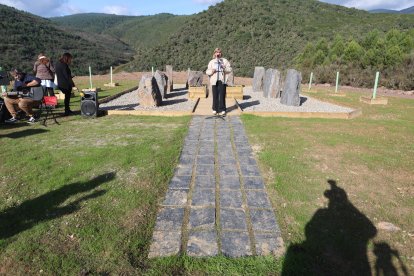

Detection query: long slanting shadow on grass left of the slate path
xmin=0 ymin=172 xmax=115 ymax=240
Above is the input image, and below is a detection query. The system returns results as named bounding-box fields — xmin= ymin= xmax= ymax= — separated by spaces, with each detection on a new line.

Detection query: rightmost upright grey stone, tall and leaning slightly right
xmin=280 ymin=69 xmax=302 ymax=106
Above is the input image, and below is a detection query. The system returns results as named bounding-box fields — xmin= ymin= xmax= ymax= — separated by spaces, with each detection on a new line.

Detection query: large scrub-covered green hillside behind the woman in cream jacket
xmin=128 ymin=0 xmax=414 ymax=76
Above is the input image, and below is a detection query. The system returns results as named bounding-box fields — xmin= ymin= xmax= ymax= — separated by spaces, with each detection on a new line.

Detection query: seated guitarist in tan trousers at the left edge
xmin=2 ymin=69 xmax=41 ymax=124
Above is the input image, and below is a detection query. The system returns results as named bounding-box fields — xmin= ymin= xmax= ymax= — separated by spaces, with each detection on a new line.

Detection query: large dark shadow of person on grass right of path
xmin=282 ymin=180 xmax=377 ymax=275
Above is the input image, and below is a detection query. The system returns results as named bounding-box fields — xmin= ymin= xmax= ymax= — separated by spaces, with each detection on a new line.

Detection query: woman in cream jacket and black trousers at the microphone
xmin=206 ymin=48 xmax=232 ymax=115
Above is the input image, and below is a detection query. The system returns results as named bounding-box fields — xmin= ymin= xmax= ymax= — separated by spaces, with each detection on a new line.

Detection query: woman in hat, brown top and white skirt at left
xmin=33 ymin=54 xmax=55 ymax=96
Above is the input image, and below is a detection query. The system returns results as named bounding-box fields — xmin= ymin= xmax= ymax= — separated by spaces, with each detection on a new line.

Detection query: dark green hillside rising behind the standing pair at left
xmin=0 ymin=5 xmax=134 ymax=75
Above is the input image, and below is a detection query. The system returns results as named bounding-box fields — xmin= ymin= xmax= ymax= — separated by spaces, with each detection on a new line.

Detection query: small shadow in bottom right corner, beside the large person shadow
xmin=374 ymin=242 xmax=408 ymax=276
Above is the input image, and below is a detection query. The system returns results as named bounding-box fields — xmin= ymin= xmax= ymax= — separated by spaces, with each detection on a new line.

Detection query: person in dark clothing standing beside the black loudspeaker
xmin=55 ymin=53 xmax=76 ymax=116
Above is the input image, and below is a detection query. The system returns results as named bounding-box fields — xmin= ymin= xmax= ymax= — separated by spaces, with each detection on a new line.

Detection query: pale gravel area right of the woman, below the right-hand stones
xmin=237 ymin=87 xmax=354 ymax=113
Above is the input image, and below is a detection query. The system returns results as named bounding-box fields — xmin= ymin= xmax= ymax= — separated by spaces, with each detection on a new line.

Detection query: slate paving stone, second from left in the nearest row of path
xmin=187 ymin=231 xmax=218 ymax=257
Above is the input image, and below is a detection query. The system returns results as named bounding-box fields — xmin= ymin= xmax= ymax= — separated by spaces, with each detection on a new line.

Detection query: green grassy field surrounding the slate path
xmin=0 ymin=78 xmax=414 ymax=275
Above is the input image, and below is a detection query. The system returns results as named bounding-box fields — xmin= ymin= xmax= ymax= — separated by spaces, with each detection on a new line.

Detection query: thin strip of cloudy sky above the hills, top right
xmin=321 ymin=0 xmax=414 ymax=10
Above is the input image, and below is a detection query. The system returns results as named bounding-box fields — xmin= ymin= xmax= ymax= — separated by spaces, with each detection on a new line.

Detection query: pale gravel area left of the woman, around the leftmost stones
xmin=99 ymin=89 xmax=196 ymax=111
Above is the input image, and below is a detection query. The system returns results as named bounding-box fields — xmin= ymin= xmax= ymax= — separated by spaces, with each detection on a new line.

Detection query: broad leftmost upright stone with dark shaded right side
xmin=138 ymin=75 xmax=162 ymax=107
